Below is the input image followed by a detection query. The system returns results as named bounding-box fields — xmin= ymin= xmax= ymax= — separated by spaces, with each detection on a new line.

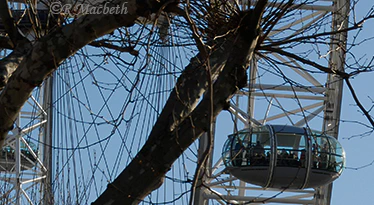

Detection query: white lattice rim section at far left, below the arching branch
xmin=0 ymin=79 xmax=52 ymax=205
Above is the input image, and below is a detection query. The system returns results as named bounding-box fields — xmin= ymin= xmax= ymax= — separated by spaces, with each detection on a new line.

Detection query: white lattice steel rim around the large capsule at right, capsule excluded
xmin=194 ymin=0 xmax=350 ymax=205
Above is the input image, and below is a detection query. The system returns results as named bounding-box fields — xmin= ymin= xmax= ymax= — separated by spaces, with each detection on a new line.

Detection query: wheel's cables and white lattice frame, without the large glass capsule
xmin=0 ymin=0 xmax=349 ymax=204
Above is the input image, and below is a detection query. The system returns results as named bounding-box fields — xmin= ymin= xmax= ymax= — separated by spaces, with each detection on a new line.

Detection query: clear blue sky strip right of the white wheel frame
xmin=332 ymin=0 xmax=374 ymax=205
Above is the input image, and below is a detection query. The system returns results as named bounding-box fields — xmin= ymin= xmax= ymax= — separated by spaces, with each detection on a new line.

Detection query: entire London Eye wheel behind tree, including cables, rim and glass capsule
xmin=0 ymin=0 xmax=366 ymax=205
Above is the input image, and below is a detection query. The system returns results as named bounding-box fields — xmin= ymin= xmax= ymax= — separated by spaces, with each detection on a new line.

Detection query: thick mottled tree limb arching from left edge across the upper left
xmin=0 ymin=0 xmax=172 ymax=147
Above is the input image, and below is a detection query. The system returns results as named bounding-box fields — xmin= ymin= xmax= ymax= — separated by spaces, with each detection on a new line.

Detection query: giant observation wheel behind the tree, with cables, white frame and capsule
xmin=0 ymin=0 xmax=349 ymax=205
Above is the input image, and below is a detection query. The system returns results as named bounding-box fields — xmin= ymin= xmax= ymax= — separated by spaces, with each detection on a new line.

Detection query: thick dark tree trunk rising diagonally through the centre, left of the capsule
xmin=93 ymin=0 xmax=267 ymax=205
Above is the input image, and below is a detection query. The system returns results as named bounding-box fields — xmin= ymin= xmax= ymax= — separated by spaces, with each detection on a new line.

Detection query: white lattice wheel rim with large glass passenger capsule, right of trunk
xmin=195 ymin=0 xmax=349 ymax=205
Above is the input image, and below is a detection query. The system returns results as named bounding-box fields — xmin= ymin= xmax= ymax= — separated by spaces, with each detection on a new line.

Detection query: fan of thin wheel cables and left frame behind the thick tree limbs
xmin=0 ymin=2 xmax=197 ymax=205
